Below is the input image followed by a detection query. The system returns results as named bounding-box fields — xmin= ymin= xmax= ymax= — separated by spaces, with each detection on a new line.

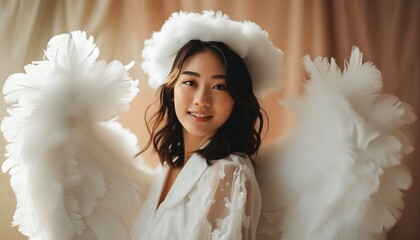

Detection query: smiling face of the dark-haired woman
xmin=174 ymin=50 xmax=234 ymax=143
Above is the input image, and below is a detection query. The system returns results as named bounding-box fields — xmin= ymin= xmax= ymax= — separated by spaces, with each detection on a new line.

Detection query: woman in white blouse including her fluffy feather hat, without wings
xmin=132 ymin=9 xmax=281 ymax=239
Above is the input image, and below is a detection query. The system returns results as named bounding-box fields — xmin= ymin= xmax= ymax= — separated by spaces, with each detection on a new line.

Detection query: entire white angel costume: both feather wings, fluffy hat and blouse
xmin=1 ymin=11 xmax=415 ymax=240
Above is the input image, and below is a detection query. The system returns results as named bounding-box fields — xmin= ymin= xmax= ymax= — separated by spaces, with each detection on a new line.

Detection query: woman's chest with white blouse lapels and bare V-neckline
xmin=133 ymin=156 xmax=208 ymax=239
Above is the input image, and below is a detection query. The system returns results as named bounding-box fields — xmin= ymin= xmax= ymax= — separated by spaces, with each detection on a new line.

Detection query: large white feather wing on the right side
xmin=257 ymin=47 xmax=416 ymax=240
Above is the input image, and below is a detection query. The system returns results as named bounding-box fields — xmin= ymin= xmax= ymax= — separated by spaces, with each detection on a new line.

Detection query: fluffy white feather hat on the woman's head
xmin=142 ymin=11 xmax=283 ymax=97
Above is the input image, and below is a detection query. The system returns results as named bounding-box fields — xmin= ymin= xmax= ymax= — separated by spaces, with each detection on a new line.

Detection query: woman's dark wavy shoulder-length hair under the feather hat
xmin=139 ymin=40 xmax=264 ymax=167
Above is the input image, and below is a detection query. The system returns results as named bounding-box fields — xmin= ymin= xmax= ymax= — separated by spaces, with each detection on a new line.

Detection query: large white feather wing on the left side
xmin=1 ymin=31 xmax=149 ymax=240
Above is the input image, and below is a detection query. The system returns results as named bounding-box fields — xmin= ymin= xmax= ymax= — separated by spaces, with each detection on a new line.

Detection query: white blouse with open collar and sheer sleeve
xmin=132 ymin=154 xmax=261 ymax=240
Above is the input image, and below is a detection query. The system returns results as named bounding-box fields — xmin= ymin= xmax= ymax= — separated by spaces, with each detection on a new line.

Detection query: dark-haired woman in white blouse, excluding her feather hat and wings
xmin=135 ymin=40 xmax=263 ymax=239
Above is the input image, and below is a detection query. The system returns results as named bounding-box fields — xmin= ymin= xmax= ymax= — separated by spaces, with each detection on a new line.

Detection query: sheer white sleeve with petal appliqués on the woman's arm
xmin=186 ymin=156 xmax=261 ymax=239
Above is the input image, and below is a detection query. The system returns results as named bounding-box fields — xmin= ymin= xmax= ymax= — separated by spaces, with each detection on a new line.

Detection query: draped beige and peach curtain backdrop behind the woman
xmin=0 ymin=0 xmax=420 ymax=240
